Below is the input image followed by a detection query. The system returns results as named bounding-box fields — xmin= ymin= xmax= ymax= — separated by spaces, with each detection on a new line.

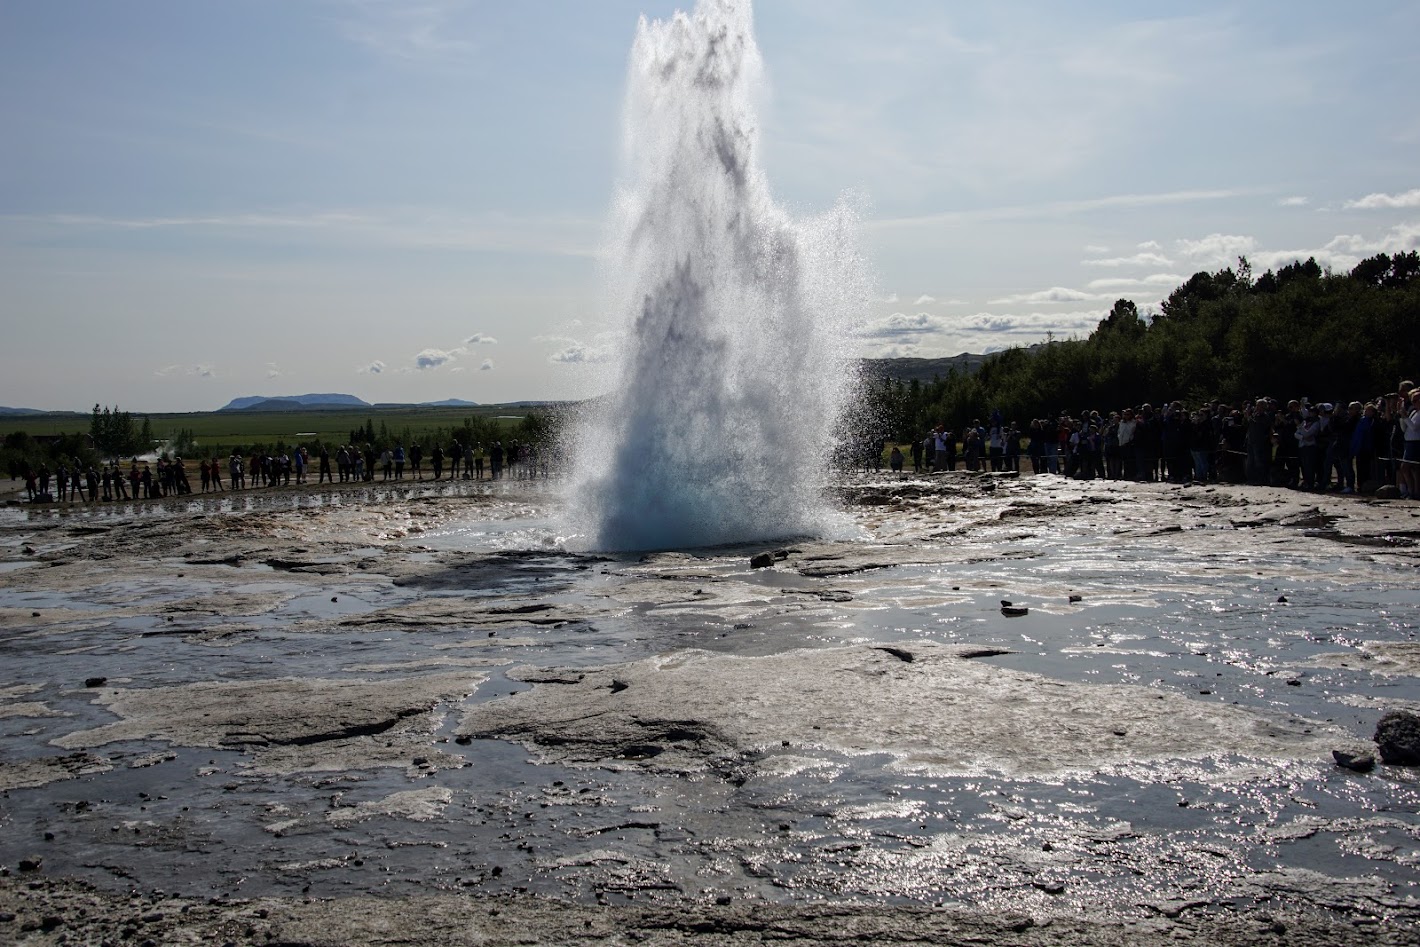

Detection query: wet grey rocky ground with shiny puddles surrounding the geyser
xmin=0 ymin=473 xmax=1420 ymax=944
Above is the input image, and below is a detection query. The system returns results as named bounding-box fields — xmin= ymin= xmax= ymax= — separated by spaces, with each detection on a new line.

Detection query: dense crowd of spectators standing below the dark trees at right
xmin=908 ymin=382 xmax=1420 ymax=498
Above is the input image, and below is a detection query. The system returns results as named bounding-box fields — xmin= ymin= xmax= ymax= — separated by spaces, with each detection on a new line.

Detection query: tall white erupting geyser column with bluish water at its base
xmin=568 ymin=0 xmax=868 ymax=551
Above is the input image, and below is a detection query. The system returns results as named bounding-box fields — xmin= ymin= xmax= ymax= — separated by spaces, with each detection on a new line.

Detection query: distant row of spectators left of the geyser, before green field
xmin=24 ymin=440 xmax=548 ymax=503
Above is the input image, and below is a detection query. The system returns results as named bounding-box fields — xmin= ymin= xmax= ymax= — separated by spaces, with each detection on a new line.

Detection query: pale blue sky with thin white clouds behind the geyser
xmin=0 ymin=0 xmax=1420 ymax=412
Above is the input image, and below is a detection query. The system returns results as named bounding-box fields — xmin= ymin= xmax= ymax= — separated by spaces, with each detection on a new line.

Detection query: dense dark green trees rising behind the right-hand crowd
xmin=859 ymin=250 xmax=1420 ymax=443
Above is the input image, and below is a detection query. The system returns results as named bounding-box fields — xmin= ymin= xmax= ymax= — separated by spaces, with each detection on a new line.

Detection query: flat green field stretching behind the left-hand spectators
xmin=0 ymin=405 xmax=548 ymax=447
